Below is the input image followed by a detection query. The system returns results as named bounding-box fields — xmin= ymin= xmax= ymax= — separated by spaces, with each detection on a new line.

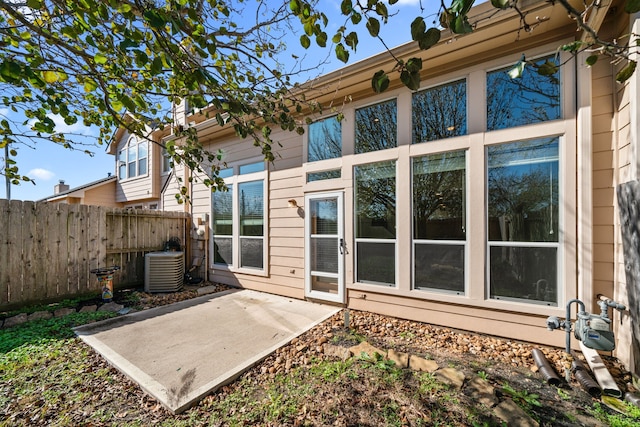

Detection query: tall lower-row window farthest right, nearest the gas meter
xmin=487 ymin=137 xmax=560 ymax=306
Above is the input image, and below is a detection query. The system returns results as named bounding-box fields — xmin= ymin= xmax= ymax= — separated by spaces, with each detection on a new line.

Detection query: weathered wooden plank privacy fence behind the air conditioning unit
xmin=0 ymin=200 xmax=190 ymax=310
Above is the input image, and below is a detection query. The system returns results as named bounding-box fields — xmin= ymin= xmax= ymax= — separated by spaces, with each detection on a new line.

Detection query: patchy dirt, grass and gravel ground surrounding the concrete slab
xmin=0 ymin=286 xmax=638 ymax=426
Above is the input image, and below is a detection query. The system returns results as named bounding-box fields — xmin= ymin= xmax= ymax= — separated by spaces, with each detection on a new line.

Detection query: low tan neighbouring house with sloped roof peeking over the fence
xmin=38 ymin=174 xmax=122 ymax=207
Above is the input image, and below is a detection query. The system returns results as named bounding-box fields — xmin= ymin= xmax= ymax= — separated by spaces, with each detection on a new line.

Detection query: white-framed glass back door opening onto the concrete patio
xmin=305 ymin=193 xmax=345 ymax=303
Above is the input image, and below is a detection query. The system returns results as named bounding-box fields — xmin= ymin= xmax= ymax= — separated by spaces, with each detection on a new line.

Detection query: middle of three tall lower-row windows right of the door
xmin=412 ymin=151 xmax=467 ymax=294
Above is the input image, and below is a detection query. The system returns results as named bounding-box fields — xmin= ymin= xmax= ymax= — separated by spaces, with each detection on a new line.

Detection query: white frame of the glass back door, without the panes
xmin=304 ymin=191 xmax=346 ymax=304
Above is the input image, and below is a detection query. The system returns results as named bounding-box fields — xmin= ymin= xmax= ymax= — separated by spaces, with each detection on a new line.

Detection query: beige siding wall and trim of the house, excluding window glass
xmin=163 ymin=0 xmax=637 ymax=354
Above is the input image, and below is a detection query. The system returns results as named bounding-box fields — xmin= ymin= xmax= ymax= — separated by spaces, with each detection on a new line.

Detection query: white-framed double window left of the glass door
xmin=211 ymin=162 xmax=266 ymax=270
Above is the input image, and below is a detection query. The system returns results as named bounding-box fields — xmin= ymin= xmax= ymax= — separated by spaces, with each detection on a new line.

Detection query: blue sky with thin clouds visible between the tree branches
xmin=0 ymin=0 xmax=439 ymax=200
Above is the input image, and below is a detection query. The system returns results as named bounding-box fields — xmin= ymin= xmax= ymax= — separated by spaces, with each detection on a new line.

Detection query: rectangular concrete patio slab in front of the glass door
xmin=75 ymin=290 xmax=340 ymax=413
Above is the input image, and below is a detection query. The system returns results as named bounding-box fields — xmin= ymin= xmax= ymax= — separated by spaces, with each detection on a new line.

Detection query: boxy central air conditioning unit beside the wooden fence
xmin=144 ymin=252 xmax=184 ymax=293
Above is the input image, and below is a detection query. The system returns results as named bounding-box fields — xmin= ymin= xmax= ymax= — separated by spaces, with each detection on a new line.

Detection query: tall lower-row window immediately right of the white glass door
xmin=354 ymin=161 xmax=396 ymax=286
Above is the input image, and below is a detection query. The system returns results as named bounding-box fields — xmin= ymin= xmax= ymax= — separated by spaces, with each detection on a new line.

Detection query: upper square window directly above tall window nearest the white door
xmin=355 ymin=99 xmax=398 ymax=154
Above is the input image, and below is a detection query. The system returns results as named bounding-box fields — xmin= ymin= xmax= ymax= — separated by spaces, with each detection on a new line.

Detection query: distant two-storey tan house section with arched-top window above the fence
xmin=107 ymin=123 xmax=171 ymax=209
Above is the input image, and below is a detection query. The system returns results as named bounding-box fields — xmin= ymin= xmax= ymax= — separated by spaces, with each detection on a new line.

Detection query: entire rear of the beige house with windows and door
xmin=161 ymin=2 xmax=639 ymax=372
